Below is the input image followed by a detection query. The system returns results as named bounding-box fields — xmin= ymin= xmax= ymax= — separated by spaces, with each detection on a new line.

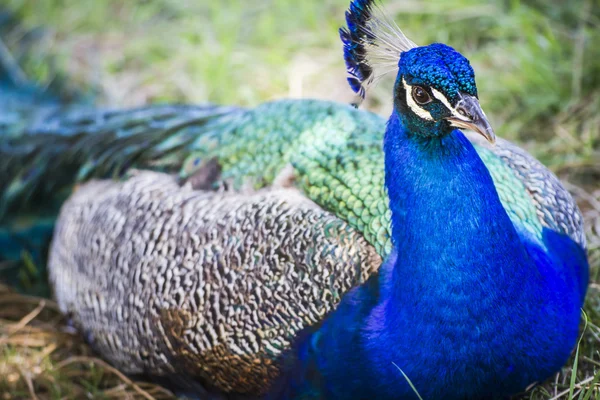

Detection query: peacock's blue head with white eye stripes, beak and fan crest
xmin=340 ymin=0 xmax=495 ymax=143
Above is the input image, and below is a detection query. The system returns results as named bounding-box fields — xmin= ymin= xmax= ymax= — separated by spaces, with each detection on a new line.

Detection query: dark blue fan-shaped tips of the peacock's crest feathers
xmin=340 ymin=0 xmax=375 ymax=99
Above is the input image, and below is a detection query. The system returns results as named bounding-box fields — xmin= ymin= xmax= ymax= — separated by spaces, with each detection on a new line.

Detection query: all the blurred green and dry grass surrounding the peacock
xmin=0 ymin=0 xmax=600 ymax=400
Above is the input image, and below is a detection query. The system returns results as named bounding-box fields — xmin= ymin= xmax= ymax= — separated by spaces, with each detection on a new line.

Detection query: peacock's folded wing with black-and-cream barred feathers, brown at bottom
xmin=49 ymin=171 xmax=381 ymax=393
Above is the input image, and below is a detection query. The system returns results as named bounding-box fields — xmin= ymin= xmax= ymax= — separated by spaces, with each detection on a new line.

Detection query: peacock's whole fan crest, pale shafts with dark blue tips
xmin=340 ymin=0 xmax=417 ymax=99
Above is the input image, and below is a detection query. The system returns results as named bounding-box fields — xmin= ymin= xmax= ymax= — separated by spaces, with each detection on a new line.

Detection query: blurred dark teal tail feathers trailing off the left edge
xmin=0 ymin=7 xmax=244 ymax=283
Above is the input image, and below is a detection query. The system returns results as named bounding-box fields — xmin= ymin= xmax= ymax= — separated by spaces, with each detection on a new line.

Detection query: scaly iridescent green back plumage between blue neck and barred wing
xmin=181 ymin=100 xmax=391 ymax=255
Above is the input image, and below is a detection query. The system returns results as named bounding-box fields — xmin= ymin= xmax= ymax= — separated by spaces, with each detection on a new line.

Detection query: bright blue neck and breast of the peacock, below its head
xmin=270 ymin=112 xmax=578 ymax=399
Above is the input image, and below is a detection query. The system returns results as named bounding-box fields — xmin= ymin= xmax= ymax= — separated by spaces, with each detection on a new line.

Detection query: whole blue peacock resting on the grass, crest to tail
xmin=0 ymin=0 xmax=588 ymax=399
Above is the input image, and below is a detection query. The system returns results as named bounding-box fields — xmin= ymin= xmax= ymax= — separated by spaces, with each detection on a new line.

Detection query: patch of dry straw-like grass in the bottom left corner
xmin=0 ymin=285 xmax=175 ymax=400
